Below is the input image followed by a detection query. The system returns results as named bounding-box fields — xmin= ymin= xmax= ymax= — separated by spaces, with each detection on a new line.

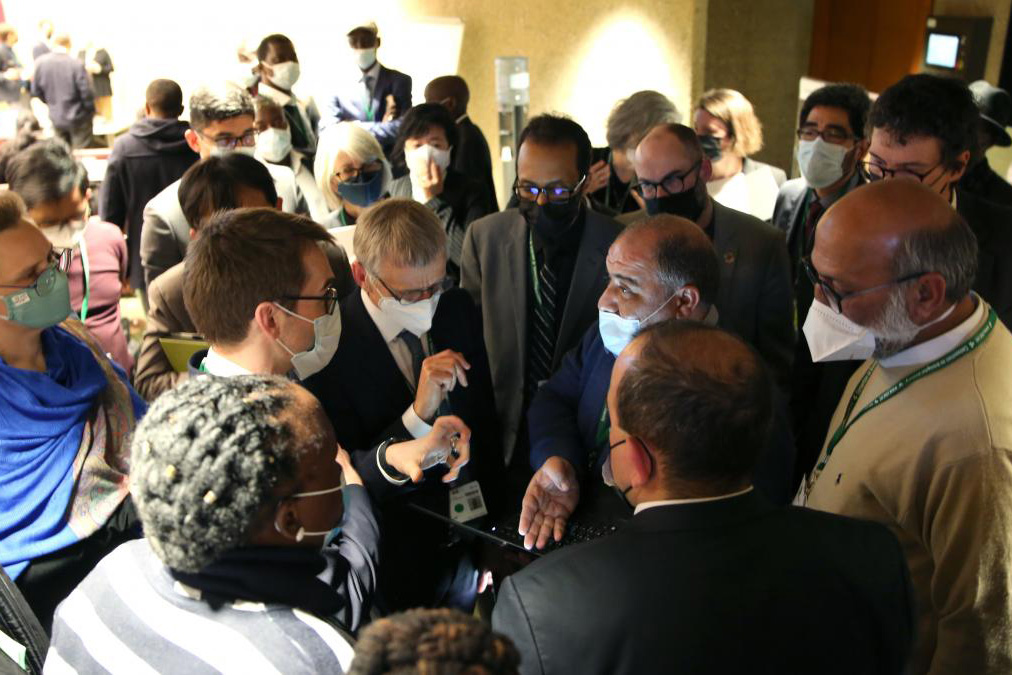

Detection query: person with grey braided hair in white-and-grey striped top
xmin=47 ymin=375 xmax=378 ymax=675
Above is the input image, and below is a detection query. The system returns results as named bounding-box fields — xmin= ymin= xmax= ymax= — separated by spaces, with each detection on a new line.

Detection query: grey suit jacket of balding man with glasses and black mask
xmin=618 ymin=202 xmax=796 ymax=384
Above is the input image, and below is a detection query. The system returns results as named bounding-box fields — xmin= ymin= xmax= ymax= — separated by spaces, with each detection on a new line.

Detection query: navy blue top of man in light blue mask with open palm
xmin=527 ymin=322 xmax=794 ymax=504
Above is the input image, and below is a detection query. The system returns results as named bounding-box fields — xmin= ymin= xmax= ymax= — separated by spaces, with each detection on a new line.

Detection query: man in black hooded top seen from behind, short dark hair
xmin=99 ymin=80 xmax=198 ymax=288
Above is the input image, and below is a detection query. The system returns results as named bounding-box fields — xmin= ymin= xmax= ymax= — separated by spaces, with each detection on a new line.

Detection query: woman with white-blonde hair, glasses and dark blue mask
xmin=313 ymin=121 xmax=393 ymax=230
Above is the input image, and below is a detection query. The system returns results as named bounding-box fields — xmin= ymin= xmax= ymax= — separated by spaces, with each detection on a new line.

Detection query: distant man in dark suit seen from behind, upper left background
xmin=31 ymin=34 xmax=95 ymax=149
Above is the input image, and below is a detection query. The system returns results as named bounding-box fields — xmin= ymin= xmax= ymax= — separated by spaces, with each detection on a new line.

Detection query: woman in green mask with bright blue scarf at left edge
xmin=0 ymin=191 xmax=145 ymax=627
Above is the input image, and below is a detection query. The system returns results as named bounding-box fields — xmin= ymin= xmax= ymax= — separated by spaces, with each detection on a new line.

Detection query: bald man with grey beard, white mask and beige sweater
xmin=799 ymin=180 xmax=1012 ymax=674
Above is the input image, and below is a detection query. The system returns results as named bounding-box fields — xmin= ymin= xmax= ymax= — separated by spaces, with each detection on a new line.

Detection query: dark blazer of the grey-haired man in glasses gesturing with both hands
xmin=306 ymin=288 xmax=501 ymax=485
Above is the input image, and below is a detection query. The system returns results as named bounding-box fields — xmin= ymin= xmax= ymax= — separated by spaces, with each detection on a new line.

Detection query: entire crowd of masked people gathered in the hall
xmin=0 ymin=14 xmax=1012 ymax=674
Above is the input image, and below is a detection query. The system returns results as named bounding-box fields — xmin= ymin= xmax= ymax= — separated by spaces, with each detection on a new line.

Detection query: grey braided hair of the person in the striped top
xmin=130 ymin=375 xmax=310 ymax=572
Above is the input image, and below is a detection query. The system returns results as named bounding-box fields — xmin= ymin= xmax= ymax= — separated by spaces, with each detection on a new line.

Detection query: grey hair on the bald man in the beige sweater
xmin=893 ymin=210 xmax=977 ymax=303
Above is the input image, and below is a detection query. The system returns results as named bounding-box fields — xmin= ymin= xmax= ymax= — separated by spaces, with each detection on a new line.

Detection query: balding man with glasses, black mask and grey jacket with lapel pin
xmin=619 ymin=123 xmax=795 ymax=392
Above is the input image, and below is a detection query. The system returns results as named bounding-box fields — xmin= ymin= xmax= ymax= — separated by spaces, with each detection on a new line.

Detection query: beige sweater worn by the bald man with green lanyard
xmin=807 ymin=308 xmax=1012 ymax=675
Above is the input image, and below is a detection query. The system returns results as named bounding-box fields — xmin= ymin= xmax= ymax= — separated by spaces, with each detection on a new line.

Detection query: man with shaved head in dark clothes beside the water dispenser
xmin=425 ymin=75 xmax=499 ymax=213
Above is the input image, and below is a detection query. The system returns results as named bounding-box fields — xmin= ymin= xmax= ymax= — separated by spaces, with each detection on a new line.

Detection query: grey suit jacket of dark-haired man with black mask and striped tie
xmin=460 ymin=204 xmax=621 ymax=462
